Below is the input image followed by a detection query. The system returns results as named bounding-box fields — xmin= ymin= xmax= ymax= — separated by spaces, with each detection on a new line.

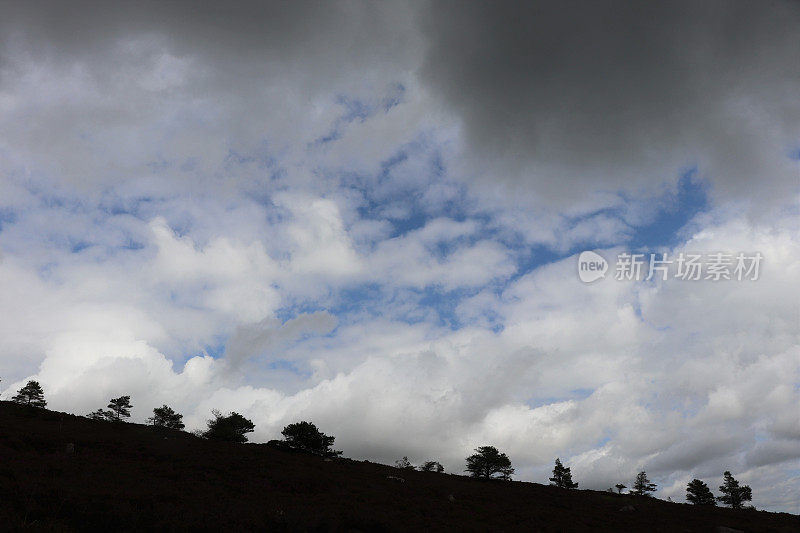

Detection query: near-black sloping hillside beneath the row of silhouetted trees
xmin=0 ymin=402 xmax=800 ymax=532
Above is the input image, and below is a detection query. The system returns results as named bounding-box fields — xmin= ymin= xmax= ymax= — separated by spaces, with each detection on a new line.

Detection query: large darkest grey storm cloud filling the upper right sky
xmin=421 ymin=1 xmax=800 ymax=206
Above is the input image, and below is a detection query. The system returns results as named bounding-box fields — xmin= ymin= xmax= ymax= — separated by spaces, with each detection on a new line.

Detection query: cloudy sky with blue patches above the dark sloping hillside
xmin=0 ymin=0 xmax=800 ymax=513
